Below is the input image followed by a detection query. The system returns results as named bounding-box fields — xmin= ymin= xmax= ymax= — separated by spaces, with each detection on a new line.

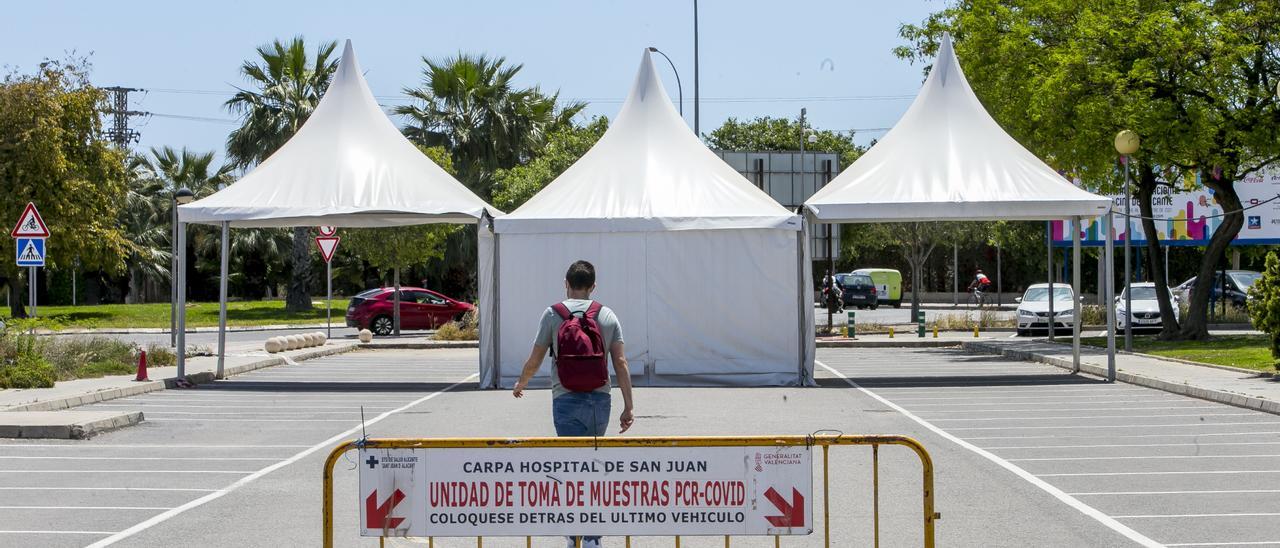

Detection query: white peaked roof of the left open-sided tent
xmin=178 ymin=40 xmax=500 ymax=227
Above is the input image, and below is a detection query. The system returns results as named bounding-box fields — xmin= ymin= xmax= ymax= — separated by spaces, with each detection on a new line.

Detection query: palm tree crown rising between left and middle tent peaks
xmin=394 ymin=54 xmax=586 ymax=198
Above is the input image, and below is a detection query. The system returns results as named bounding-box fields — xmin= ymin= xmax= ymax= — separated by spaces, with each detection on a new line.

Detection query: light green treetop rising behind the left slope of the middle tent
xmin=493 ymin=117 xmax=609 ymax=211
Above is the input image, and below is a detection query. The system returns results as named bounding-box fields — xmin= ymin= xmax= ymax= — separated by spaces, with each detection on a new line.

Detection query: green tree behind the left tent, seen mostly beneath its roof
xmin=339 ymin=146 xmax=460 ymax=333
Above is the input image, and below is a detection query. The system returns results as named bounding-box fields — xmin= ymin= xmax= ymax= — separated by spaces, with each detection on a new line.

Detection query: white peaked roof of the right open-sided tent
xmin=805 ymin=36 xmax=1111 ymax=223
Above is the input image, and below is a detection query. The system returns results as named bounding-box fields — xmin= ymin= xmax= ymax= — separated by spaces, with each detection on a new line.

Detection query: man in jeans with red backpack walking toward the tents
xmin=512 ymin=261 xmax=635 ymax=548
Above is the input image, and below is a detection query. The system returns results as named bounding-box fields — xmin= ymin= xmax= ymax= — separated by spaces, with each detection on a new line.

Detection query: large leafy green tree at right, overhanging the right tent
xmin=899 ymin=0 xmax=1280 ymax=339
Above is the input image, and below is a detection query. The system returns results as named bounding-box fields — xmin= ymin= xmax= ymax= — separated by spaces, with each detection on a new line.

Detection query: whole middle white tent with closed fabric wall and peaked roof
xmin=480 ymin=51 xmax=814 ymax=387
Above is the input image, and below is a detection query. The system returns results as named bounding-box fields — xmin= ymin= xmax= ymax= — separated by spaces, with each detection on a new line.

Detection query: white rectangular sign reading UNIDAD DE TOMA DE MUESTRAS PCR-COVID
xmin=360 ymin=446 xmax=813 ymax=536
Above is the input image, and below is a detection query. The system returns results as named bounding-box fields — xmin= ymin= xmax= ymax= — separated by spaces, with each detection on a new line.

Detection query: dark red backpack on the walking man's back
xmin=552 ymin=301 xmax=609 ymax=392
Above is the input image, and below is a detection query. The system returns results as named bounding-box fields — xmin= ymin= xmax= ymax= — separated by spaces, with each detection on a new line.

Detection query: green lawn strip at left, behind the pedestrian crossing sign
xmin=0 ymin=298 xmax=347 ymax=329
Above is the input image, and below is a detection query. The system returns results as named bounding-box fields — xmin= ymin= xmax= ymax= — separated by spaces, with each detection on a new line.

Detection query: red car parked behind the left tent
xmin=347 ymin=287 xmax=475 ymax=335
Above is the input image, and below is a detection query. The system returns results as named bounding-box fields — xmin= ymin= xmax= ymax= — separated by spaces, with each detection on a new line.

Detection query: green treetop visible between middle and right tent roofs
xmin=705 ymin=117 xmax=867 ymax=169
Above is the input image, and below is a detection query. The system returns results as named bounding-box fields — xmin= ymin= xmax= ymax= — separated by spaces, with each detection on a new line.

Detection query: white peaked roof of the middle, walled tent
xmin=494 ymin=50 xmax=800 ymax=233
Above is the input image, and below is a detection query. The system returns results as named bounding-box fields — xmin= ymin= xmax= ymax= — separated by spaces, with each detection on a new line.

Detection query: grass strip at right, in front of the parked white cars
xmin=1080 ymin=335 xmax=1276 ymax=371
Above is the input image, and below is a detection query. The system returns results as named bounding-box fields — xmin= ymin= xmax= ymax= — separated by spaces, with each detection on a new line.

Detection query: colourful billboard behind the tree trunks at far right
xmin=1051 ymin=166 xmax=1280 ymax=247
